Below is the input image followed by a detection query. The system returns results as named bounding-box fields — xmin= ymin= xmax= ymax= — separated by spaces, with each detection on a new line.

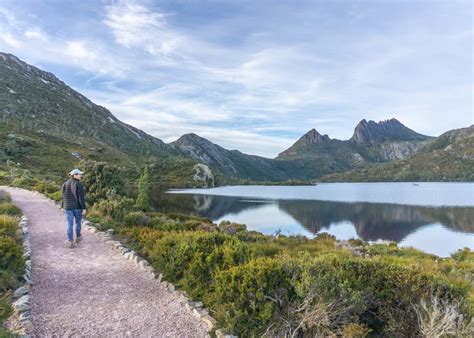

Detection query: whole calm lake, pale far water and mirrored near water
xmin=155 ymin=183 xmax=474 ymax=256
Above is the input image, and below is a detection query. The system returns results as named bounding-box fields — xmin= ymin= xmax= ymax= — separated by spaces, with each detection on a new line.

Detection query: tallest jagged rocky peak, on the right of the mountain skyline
xmin=350 ymin=118 xmax=429 ymax=143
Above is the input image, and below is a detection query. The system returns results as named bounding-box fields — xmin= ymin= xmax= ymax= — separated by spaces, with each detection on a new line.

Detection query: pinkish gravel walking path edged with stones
xmin=5 ymin=188 xmax=207 ymax=337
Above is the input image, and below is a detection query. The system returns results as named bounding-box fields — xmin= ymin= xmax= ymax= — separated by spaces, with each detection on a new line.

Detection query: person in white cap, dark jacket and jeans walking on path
xmin=61 ymin=169 xmax=86 ymax=248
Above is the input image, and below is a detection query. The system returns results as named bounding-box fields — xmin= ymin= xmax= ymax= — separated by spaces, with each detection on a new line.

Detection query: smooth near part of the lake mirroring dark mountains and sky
xmin=154 ymin=193 xmax=474 ymax=256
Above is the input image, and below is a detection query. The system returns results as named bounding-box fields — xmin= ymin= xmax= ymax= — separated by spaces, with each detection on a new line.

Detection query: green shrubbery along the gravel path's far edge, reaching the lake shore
xmin=1 ymin=161 xmax=474 ymax=337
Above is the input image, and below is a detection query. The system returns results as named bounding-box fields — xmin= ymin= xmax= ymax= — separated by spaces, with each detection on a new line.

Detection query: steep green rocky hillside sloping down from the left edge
xmin=0 ymin=53 xmax=195 ymax=185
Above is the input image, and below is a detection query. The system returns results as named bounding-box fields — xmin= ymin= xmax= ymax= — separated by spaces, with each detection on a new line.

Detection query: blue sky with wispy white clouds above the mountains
xmin=0 ymin=0 xmax=474 ymax=157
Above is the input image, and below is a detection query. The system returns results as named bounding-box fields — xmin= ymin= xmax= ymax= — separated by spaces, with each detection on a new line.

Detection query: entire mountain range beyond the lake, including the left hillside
xmin=0 ymin=53 xmax=474 ymax=186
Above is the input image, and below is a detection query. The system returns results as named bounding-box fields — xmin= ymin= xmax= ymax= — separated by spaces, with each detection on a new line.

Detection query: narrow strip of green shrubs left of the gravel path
xmin=0 ymin=193 xmax=25 ymax=336
